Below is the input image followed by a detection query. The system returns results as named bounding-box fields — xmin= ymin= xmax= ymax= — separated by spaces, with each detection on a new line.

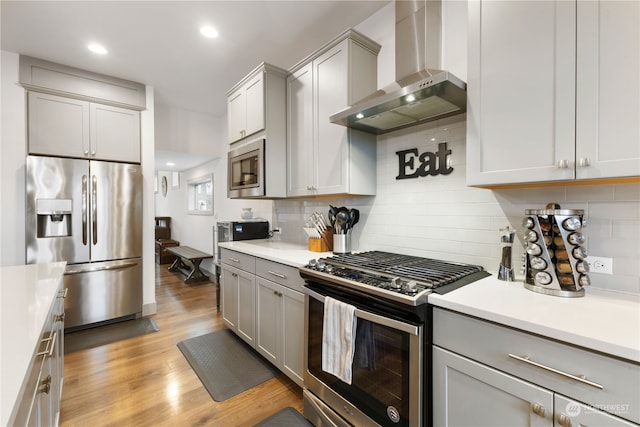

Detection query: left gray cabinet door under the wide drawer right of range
xmin=433 ymin=346 xmax=553 ymax=427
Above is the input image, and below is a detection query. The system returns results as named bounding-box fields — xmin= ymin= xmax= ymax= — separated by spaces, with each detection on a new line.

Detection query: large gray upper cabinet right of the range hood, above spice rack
xmin=467 ymin=0 xmax=640 ymax=186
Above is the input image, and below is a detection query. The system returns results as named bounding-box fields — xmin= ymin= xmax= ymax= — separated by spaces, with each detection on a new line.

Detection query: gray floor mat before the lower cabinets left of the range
xmin=178 ymin=329 xmax=280 ymax=402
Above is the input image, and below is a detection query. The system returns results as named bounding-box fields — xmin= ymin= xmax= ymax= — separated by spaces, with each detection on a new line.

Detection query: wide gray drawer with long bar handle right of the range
xmin=433 ymin=308 xmax=640 ymax=423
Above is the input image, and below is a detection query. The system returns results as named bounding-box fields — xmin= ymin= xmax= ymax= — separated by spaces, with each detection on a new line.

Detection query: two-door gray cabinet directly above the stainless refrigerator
xmin=28 ymin=92 xmax=140 ymax=163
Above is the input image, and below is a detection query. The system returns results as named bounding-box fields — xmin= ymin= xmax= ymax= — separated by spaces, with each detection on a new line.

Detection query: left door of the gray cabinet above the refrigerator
xmin=28 ymin=92 xmax=90 ymax=158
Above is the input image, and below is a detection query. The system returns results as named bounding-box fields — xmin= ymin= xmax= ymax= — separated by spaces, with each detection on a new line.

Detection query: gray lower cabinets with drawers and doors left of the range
xmin=220 ymin=249 xmax=304 ymax=387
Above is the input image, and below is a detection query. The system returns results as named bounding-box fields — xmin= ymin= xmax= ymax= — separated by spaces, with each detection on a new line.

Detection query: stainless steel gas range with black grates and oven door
xmin=300 ymin=251 xmax=489 ymax=426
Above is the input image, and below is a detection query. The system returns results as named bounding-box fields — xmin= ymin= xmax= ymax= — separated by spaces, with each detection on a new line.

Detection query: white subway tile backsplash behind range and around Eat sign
xmin=273 ymin=116 xmax=640 ymax=294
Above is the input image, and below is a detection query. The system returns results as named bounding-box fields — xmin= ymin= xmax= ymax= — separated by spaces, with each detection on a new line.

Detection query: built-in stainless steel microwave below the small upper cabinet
xmin=227 ymin=139 xmax=265 ymax=199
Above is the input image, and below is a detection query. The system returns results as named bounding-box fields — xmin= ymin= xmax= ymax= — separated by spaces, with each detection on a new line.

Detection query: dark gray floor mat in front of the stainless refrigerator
xmin=64 ymin=317 xmax=160 ymax=354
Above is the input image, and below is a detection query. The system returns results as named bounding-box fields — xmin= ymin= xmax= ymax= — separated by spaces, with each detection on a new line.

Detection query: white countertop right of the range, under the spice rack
xmin=429 ymin=276 xmax=640 ymax=362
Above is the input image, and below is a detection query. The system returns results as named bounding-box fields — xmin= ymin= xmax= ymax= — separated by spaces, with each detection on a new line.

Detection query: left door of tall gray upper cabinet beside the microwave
xmin=287 ymin=63 xmax=314 ymax=196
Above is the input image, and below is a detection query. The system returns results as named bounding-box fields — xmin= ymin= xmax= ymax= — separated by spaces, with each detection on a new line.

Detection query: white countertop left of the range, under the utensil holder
xmin=220 ymin=239 xmax=333 ymax=267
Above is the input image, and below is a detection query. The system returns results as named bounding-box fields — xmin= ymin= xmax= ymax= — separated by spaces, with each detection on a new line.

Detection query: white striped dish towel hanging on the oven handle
xmin=322 ymin=297 xmax=357 ymax=384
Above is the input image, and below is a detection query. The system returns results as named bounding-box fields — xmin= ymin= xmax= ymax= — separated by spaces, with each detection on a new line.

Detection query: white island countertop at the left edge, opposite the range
xmin=0 ymin=262 xmax=66 ymax=426
